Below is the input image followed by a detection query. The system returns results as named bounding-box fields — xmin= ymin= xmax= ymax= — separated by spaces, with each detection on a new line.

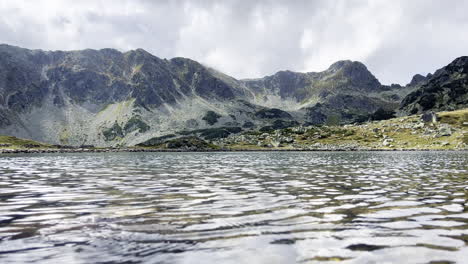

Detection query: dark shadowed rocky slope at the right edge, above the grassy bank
xmin=401 ymin=56 xmax=468 ymax=114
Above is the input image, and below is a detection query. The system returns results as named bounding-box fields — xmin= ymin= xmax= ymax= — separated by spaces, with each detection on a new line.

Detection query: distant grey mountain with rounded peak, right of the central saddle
xmin=243 ymin=61 xmax=412 ymax=124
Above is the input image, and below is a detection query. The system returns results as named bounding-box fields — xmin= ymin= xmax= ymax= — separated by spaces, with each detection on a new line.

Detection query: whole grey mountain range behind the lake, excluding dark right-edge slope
xmin=0 ymin=45 xmax=455 ymax=146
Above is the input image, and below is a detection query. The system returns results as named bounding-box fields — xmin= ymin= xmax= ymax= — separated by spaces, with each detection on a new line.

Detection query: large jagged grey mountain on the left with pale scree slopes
xmin=0 ymin=45 xmax=255 ymax=146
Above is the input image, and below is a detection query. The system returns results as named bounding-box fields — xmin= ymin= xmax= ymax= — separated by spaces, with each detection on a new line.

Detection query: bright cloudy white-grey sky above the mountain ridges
xmin=0 ymin=0 xmax=468 ymax=84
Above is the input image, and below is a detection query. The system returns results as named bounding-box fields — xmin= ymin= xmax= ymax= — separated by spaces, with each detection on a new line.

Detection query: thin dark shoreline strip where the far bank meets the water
xmin=0 ymin=148 xmax=468 ymax=155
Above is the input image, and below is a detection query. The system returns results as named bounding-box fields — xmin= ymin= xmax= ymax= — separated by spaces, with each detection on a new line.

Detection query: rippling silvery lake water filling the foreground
xmin=0 ymin=152 xmax=468 ymax=264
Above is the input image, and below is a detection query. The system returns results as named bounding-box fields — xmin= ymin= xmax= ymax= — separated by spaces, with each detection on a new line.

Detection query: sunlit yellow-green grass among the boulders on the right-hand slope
xmin=225 ymin=109 xmax=468 ymax=150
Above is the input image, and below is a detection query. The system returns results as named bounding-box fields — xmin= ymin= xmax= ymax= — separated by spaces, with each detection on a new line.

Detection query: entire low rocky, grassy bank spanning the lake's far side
xmin=0 ymin=109 xmax=468 ymax=154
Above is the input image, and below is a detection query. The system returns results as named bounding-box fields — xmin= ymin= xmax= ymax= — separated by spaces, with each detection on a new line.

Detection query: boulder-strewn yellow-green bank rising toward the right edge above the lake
xmin=222 ymin=109 xmax=468 ymax=150
